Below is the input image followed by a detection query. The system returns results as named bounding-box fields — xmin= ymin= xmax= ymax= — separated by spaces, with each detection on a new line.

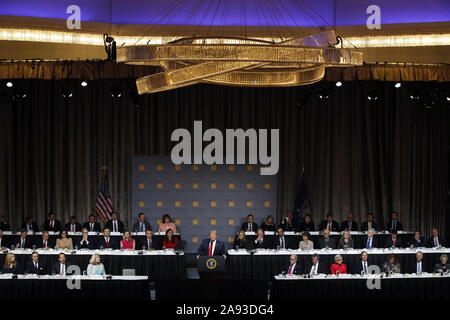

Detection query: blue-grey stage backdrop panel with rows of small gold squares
xmin=130 ymin=156 xmax=277 ymax=252
